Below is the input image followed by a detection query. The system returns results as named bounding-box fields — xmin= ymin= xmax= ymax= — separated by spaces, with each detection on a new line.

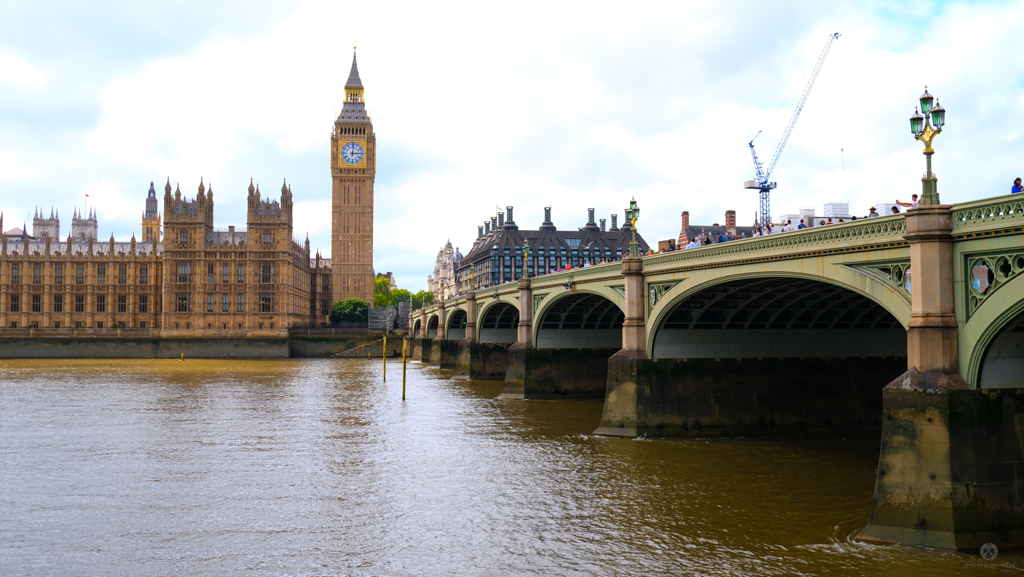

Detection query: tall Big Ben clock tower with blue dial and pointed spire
xmin=331 ymin=50 xmax=377 ymax=304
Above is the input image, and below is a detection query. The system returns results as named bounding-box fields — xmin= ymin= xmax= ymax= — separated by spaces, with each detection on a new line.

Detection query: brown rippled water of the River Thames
xmin=0 ymin=360 xmax=1024 ymax=576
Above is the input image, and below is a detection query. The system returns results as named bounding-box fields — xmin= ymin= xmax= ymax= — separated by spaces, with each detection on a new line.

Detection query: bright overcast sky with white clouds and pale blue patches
xmin=0 ymin=0 xmax=1024 ymax=290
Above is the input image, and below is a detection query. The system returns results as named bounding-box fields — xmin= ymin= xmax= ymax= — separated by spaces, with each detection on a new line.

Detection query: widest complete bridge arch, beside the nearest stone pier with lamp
xmin=647 ymin=274 xmax=909 ymax=360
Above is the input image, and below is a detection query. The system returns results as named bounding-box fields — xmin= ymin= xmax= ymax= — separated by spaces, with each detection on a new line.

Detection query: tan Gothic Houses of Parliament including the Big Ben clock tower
xmin=0 ymin=53 xmax=377 ymax=336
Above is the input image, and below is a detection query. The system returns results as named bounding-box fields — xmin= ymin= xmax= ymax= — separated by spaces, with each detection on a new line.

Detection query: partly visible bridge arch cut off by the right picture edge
xmin=959 ymin=275 xmax=1024 ymax=388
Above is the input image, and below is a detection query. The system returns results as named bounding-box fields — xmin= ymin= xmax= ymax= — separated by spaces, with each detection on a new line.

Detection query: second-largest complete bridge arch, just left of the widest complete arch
xmin=534 ymin=290 xmax=626 ymax=349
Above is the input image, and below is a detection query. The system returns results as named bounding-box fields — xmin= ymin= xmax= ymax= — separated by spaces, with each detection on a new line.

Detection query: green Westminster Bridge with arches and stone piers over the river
xmin=411 ymin=196 xmax=1024 ymax=549
